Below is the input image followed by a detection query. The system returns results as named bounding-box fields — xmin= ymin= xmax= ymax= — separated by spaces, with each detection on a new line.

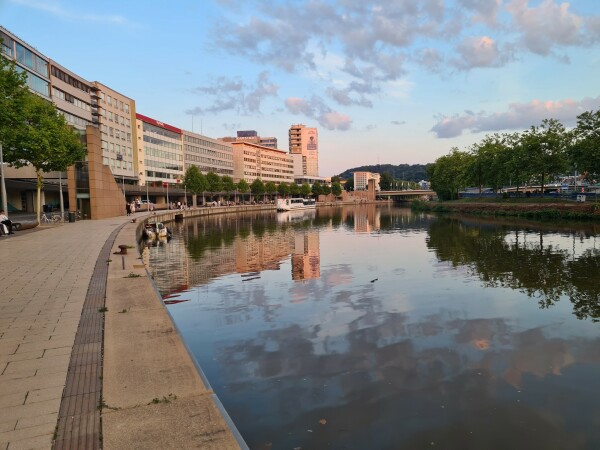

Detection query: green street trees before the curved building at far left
xmin=0 ymin=46 xmax=86 ymax=222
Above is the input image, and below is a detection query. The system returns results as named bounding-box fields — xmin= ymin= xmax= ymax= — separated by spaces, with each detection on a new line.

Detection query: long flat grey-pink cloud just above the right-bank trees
xmin=431 ymin=97 xmax=600 ymax=138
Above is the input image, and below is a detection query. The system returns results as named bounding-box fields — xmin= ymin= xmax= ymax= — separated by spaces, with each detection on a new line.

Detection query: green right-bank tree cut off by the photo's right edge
xmin=568 ymin=110 xmax=600 ymax=179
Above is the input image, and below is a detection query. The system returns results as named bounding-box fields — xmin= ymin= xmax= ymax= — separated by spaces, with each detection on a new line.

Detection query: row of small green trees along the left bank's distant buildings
xmin=183 ymin=166 xmax=342 ymax=206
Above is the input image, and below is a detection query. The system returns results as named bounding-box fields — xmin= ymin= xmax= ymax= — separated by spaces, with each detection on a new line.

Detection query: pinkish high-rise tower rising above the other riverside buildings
xmin=289 ymin=124 xmax=319 ymax=177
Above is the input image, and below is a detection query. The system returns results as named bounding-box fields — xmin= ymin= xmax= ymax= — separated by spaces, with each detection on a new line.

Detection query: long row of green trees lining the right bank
xmin=428 ymin=110 xmax=600 ymax=200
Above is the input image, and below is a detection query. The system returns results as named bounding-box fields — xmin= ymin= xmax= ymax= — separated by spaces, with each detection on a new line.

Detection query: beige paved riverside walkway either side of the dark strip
xmin=0 ymin=214 xmax=243 ymax=450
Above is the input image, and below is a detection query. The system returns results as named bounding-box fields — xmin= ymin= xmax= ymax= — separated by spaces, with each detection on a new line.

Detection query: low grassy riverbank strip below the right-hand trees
xmin=411 ymin=199 xmax=600 ymax=220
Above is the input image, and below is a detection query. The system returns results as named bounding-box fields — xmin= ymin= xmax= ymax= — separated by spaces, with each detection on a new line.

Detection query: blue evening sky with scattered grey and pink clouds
xmin=0 ymin=0 xmax=600 ymax=176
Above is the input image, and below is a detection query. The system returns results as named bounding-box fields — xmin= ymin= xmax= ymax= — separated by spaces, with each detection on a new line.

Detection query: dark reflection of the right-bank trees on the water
xmin=427 ymin=218 xmax=600 ymax=322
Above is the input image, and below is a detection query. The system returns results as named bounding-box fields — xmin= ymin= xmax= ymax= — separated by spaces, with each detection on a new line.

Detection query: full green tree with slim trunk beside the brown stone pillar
xmin=5 ymin=94 xmax=85 ymax=222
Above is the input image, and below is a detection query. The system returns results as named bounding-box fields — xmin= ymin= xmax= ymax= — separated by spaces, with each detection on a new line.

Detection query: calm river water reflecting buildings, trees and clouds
xmin=143 ymin=205 xmax=600 ymax=450
